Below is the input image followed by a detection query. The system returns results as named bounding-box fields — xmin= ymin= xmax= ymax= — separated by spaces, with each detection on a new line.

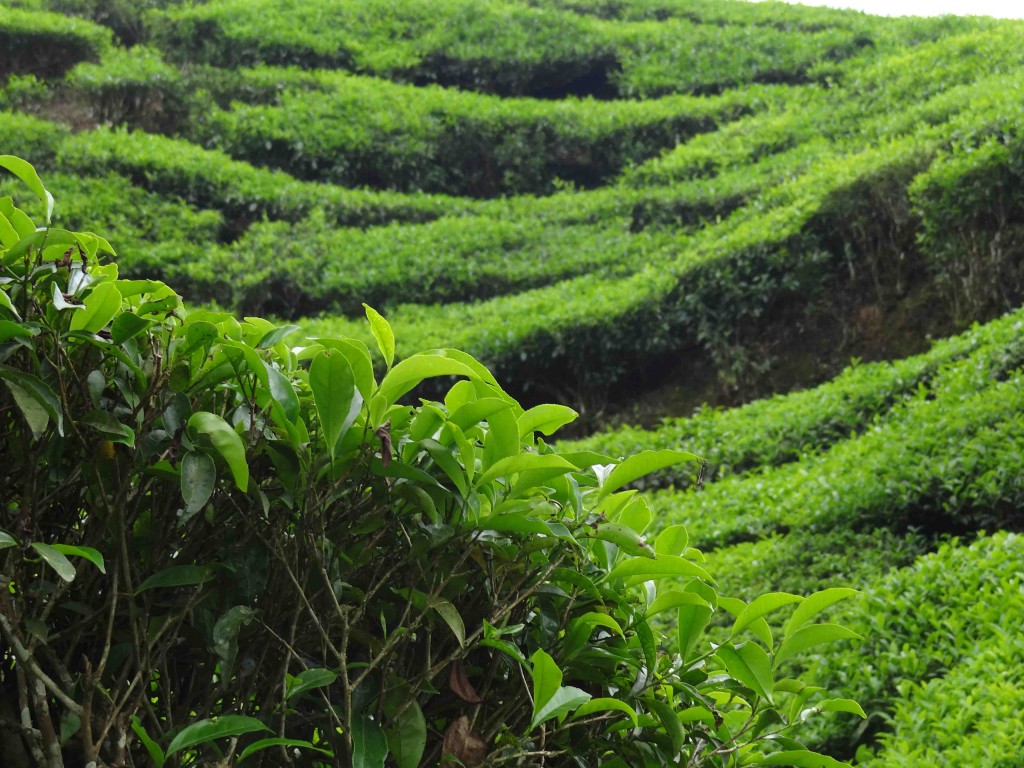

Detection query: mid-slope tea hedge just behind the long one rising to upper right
xmin=173 ymin=214 xmax=666 ymax=316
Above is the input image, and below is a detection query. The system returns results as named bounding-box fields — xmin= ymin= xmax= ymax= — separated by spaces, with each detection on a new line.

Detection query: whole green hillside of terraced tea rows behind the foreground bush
xmin=0 ymin=0 xmax=1024 ymax=768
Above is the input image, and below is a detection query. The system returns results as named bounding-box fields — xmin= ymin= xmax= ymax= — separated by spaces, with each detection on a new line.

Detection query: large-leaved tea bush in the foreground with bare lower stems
xmin=0 ymin=156 xmax=860 ymax=768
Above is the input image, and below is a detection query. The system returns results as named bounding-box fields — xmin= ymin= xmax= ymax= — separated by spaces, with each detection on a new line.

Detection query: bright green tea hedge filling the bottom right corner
xmin=814 ymin=532 xmax=1024 ymax=768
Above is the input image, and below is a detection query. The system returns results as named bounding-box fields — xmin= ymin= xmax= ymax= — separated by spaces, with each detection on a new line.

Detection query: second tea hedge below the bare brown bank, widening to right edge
xmin=651 ymin=354 xmax=1024 ymax=546
